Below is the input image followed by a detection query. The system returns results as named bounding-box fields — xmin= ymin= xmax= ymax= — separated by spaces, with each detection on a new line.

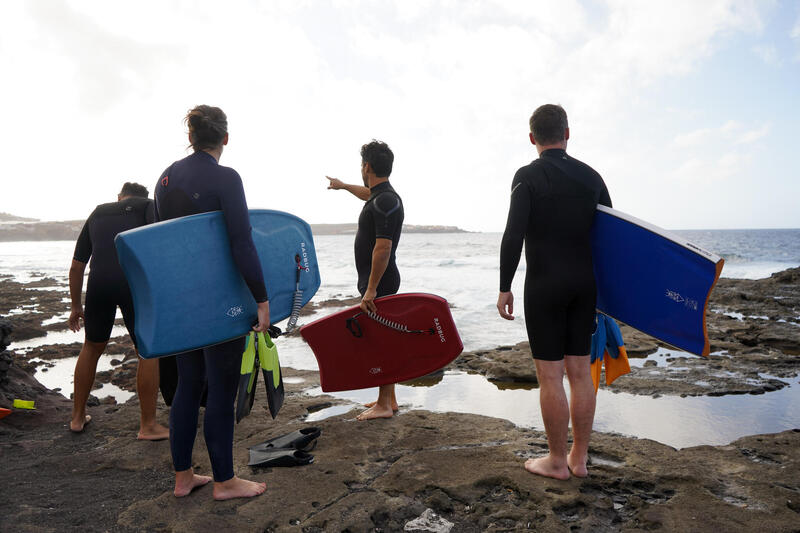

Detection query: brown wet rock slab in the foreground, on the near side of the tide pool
xmin=0 ymin=372 xmax=800 ymax=532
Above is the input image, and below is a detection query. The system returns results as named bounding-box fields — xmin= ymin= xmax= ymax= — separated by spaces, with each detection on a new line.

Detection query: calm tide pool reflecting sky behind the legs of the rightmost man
xmin=307 ymin=372 xmax=800 ymax=448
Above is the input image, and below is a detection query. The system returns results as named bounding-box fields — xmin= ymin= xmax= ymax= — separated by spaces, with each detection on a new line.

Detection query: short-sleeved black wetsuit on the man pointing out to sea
xmin=354 ymin=181 xmax=405 ymax=296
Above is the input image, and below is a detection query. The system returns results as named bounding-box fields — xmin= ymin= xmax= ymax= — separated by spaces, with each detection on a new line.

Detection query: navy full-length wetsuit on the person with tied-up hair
xmin=155 ymin=151 xmax=267 ymax=481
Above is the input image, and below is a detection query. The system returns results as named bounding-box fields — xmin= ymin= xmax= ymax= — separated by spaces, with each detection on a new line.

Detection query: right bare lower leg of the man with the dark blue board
xmin=565 ymin=355 xmax=596 ymax=477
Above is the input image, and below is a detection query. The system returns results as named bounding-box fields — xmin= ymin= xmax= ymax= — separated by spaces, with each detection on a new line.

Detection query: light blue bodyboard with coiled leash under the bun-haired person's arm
xmin=114 ymin=209 xmax=320 ymax=358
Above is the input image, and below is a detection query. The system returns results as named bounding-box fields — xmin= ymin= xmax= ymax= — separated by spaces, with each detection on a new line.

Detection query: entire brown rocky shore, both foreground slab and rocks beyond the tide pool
xmin=0 ymin=269 xmax=800 ymax=532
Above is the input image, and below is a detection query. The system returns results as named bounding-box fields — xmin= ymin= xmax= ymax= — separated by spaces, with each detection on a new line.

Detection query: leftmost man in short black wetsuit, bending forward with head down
xmin=69 ymin=183 xmax=169 ymax=440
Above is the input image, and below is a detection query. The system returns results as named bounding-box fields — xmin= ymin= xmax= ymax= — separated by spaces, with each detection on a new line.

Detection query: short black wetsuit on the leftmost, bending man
xmin=73 ymin=197 xmax=153 ymax=345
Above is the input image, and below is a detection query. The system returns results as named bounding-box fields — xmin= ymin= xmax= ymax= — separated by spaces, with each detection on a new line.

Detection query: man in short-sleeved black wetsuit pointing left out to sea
xmin=326 ymin=141 xmax=404 ymax=420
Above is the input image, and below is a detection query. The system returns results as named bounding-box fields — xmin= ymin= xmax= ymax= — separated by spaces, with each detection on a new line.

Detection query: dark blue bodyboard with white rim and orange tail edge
xmin=592 ymin=205 xmax=724 ymax=355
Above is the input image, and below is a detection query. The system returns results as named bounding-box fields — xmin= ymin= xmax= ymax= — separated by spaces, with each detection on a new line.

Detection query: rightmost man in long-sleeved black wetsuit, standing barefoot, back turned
xmin=497 ymin=104 xmax=611 ymax=479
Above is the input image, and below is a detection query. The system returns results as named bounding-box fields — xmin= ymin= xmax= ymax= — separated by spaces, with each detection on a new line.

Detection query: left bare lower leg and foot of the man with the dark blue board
xmin=525 ymin=359 xmax=569 ymax=480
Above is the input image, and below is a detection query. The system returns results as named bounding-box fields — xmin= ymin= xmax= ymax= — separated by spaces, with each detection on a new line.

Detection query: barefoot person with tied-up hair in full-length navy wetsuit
xmin=155 ymin=105 xmax=269 ymax=500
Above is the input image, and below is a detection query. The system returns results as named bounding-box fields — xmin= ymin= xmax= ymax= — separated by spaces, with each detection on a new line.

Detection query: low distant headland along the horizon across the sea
xmin=0 ymin=213 xmax=467 ymax=242
